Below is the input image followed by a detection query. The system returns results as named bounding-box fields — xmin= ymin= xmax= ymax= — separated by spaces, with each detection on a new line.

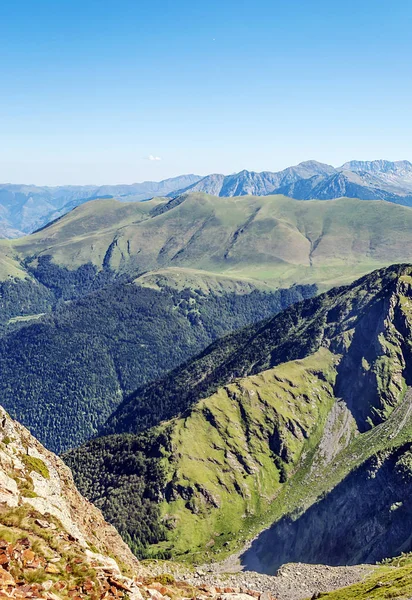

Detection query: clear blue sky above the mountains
xmin=0 ymin=0 xmax=412 ymax=185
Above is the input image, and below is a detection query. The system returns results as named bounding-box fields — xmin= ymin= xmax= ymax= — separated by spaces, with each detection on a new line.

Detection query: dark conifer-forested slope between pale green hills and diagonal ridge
xmin=0 ymin=283 xmax=314 ymax=452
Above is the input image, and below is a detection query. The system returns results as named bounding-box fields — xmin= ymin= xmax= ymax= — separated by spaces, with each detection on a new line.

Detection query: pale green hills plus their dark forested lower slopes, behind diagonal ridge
xmin=0 ymin=192 xmax=412 ymax=452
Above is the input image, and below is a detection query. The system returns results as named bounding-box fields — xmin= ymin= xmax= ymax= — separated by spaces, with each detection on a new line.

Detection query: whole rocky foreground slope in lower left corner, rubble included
xmin=0 ymin=407 xmax=148 ymax=600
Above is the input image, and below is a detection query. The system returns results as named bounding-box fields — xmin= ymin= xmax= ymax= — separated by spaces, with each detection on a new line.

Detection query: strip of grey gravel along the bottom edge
xmin=150 ymin=561 xmax=375 ymax=600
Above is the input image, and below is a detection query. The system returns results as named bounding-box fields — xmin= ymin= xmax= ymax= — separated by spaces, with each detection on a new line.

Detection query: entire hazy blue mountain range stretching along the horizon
xmin=4 ymin=160 xmax=412 ymax=238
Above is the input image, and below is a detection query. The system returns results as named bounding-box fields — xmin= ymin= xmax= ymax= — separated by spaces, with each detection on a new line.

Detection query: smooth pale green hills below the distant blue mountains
xmin=0 ymin=193 xmax=412 ymax=288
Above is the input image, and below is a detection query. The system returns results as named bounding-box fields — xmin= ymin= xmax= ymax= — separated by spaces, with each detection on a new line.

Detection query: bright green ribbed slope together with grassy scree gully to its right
xmin=149 ymin=275 xmax=412 ymax=559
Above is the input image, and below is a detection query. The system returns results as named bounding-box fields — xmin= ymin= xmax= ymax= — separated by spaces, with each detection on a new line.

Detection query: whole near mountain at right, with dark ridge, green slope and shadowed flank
xmin=67 ymin=266 xmax=412 ymax=573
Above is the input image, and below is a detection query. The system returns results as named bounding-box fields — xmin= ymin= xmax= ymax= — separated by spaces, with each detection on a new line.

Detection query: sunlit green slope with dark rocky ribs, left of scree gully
xmin=154 ymin=350 xmax=335 ymax=554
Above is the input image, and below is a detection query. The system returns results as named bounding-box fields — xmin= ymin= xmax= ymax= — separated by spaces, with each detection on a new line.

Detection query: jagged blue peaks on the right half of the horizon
xmin=169 ymin=160 xmax=412 ymax=206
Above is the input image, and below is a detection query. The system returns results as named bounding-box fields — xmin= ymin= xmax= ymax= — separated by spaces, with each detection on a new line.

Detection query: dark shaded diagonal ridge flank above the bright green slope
xmin=105 ymin=266 xmax=407 ymax=433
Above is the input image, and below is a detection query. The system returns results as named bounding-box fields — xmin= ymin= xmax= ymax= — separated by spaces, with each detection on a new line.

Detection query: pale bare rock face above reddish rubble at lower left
xmin=0 ymin=407 xmax=138 ymax=569
